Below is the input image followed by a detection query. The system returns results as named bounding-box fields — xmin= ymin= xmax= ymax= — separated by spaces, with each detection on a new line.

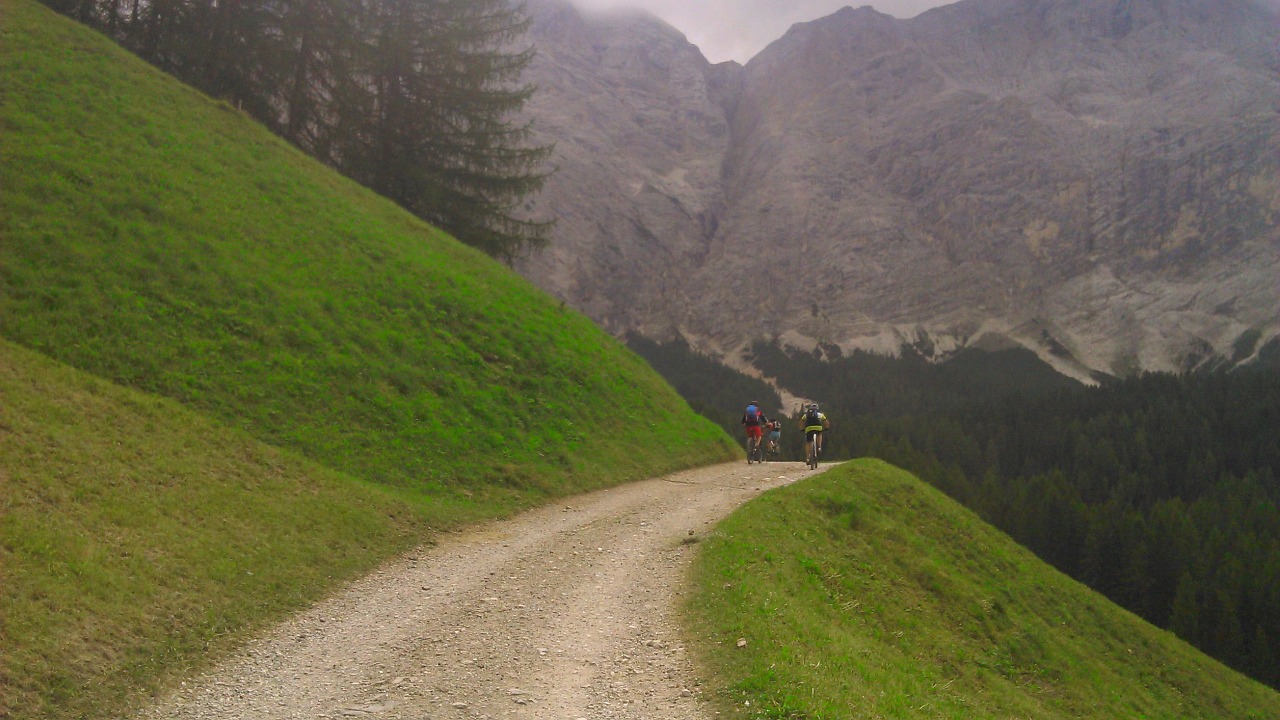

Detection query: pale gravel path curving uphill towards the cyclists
xmin=138 ymin=462 xmax=810 ymax=720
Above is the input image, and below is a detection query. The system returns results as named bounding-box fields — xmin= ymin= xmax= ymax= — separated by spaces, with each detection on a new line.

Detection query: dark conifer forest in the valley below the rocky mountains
xmin=632 ymin=333 xmax=1280 ymax=688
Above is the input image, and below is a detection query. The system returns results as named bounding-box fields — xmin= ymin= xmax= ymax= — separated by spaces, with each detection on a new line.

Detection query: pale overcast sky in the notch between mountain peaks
xmin=572 ymin=0 xmax=955 ymax=63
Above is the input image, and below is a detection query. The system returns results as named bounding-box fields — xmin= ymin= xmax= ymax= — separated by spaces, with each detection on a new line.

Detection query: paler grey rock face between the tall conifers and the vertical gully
xmin=520 ymin=0 xmax=742 ymax=333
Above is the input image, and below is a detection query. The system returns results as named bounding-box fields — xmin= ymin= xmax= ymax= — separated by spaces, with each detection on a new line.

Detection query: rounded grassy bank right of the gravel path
xmin=686 ymin=460 xmax=1280 ymax=720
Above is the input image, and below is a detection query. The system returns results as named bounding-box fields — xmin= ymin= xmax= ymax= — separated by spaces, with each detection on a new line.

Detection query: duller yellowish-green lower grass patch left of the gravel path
xmin=0 ymin=341 xmax=424 ymax=720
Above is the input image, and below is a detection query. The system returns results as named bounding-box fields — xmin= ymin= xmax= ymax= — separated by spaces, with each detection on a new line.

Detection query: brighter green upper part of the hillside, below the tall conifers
xmin=0 ymin=0 xmax=733 ymax=504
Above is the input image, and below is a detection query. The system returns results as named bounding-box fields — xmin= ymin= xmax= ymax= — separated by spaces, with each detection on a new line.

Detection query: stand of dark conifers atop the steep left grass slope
xmin=44 ymin=0 xmax=550 ymax=259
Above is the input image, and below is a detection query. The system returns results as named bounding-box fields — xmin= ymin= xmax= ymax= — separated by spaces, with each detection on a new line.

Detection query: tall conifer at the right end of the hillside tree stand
xmin=337 ymin=0 xmax=550 ymax=260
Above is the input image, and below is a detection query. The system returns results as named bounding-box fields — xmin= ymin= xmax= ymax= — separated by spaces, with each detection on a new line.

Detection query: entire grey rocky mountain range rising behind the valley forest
xmin=518 ymin=0 xmax=1280 ymax=377
